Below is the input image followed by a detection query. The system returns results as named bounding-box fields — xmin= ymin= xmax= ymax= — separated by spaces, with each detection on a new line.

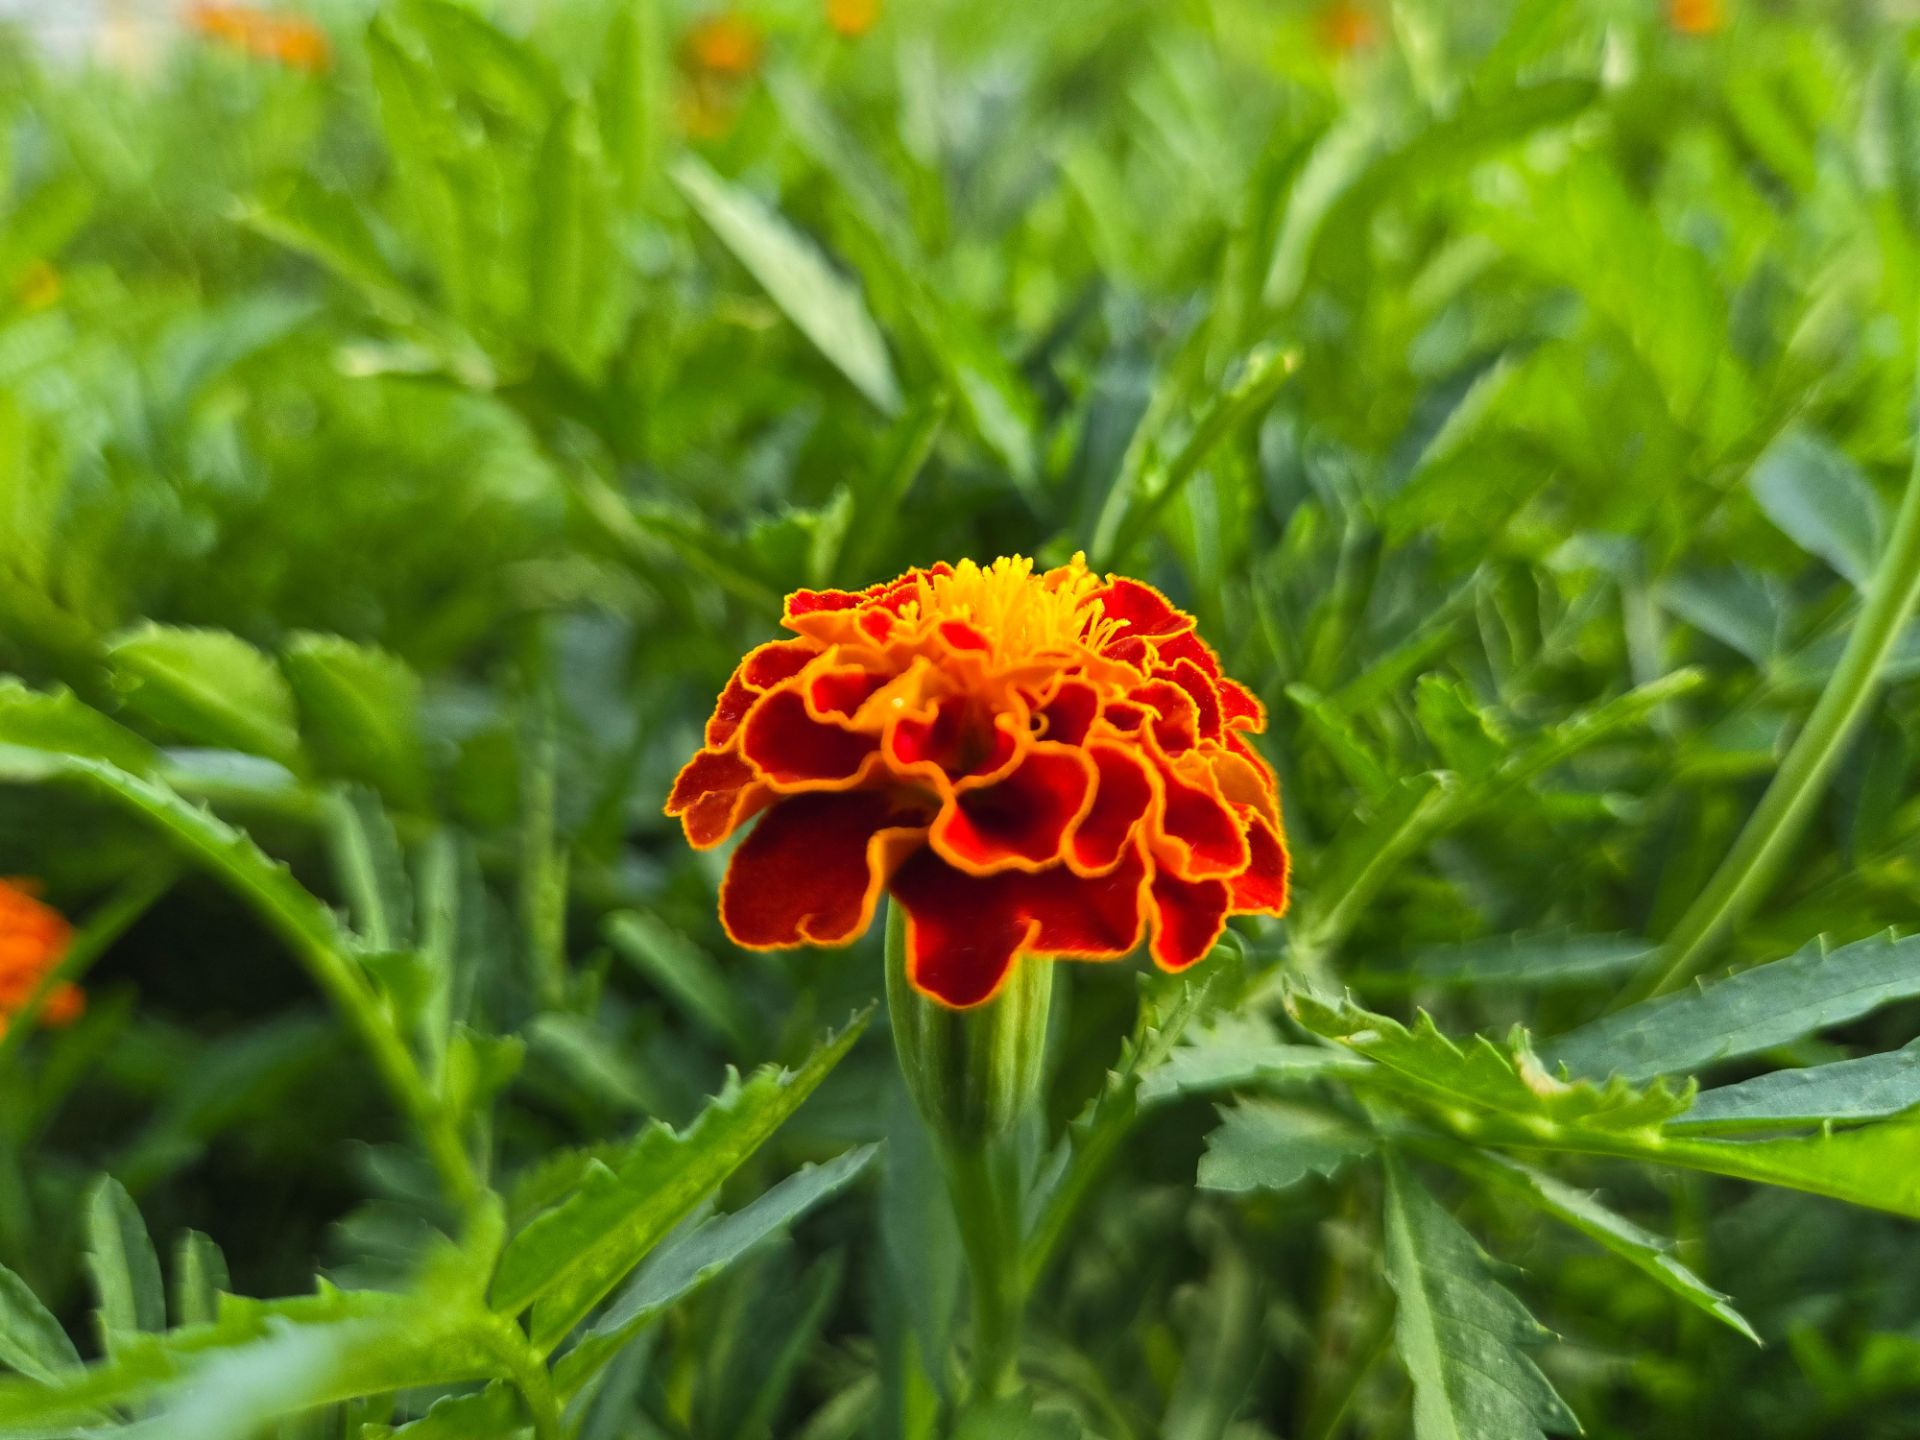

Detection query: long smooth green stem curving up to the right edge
xmin=1628 ymin=422 xmax=1920 ymax=998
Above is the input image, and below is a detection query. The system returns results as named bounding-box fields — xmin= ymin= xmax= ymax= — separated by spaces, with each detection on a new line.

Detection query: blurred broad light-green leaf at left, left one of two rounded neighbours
xmin=108 ymin=624 xmax=300 ymax=768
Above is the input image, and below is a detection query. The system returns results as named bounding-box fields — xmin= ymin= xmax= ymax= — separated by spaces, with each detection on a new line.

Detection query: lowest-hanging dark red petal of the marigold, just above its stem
xmin=891 ymin=851 xmax=1039 ymax=1008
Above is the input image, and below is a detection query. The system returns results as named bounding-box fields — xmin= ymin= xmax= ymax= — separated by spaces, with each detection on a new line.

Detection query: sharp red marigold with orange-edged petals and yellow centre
xmin=666 ymin=557 xmax=1286 ymax=1006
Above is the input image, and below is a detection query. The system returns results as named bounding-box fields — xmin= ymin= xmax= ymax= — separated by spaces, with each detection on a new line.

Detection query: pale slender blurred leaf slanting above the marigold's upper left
xmin=670 ymin=156 xmax=900 ymax=415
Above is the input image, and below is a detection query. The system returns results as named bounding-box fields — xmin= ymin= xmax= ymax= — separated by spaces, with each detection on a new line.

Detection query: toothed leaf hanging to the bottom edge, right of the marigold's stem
xmin=1384 ymin=1162 xmax=1580 ymax=1440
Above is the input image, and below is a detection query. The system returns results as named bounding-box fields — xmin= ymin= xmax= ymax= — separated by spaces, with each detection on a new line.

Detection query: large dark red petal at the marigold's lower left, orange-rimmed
xmin=720 ymin=791 xmax=918 ymax=950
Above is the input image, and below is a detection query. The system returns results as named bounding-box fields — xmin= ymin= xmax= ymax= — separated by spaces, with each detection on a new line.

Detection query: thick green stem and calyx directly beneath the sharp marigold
xmin=887 ymin=906 xmax=1054 ymax=1396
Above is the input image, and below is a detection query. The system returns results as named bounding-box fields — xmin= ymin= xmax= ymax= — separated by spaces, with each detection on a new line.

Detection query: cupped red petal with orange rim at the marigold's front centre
xmin=929 ymin=741 xmax=1094 ymax=874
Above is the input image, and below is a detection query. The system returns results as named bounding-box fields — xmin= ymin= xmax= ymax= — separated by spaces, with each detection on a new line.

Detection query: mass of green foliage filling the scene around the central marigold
xmin=0 ymin=0 xmax=1920 ymax=1440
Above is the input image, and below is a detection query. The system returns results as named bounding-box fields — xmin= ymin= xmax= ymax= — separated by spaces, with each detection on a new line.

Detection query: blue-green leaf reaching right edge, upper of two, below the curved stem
xmin=1544 ymin=933 xmax=1920 ymax=1081
